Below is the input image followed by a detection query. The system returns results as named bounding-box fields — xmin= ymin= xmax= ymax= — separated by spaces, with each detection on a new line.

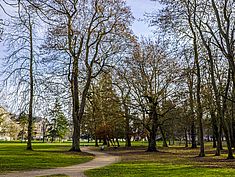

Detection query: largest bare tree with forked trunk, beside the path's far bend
xmin=37 ymin=0 xmax=132 ymax=151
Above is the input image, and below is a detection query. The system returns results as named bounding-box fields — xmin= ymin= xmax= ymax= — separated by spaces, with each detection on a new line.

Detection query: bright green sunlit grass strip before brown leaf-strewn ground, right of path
xmin=85 ymin=163 xmax=235 ymax=177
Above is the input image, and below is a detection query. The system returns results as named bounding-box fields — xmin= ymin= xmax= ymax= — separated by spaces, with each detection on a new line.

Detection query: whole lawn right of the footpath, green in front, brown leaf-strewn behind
xmin=85 ymin=144 xmax=235 ymax=177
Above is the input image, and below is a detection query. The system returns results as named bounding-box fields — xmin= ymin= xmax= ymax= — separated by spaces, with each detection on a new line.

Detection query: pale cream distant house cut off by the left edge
xmin=0 ymin=106 xmax=20 ymax=141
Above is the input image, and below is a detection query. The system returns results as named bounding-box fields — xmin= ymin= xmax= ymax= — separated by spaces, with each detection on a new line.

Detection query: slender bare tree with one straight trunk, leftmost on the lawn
xmin=1 ymin=1 xmax=39 ymax=150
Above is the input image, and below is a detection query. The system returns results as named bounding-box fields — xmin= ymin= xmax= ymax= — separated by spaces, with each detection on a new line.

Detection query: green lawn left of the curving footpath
xmin=0 ymin=143 xmax=93 ymax=173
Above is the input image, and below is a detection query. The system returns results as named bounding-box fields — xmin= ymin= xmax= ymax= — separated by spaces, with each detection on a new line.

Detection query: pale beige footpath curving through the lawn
xmin=0 ymin=148 xmax=120 ymax=177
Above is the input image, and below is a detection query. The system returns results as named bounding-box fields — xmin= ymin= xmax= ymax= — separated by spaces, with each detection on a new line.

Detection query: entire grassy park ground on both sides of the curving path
xmin=0 ymin=142 xmax=235 ymax=177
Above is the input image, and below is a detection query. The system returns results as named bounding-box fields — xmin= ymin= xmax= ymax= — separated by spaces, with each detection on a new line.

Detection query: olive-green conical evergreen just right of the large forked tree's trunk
xmin=98 ymin=73 xmax=125 ymax=146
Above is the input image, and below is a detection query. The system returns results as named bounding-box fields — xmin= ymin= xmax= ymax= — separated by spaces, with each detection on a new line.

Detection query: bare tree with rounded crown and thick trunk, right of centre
xmin=128 ymin=39 xmax=177 ymax=152
